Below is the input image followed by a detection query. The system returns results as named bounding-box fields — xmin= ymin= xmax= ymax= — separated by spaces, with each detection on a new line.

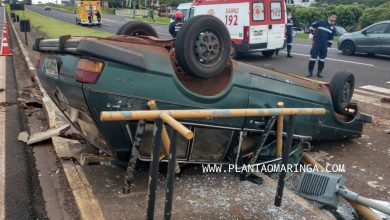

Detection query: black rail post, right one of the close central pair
xmin=164 ymin=129 xmax=177 ymax=220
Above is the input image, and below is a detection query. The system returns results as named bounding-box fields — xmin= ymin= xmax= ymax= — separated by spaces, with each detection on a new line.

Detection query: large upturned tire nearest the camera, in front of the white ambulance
xmin=175 ymin=15 xmax=231 ymax=78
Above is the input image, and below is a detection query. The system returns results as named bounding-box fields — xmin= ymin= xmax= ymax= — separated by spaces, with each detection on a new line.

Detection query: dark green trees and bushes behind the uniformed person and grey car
xmin=287 ymin=0 xmax=390 ymax=31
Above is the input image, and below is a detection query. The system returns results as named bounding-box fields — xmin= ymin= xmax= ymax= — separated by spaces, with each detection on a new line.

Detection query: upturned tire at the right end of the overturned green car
xmin=329 ymin=71 xmax=355 ymax=113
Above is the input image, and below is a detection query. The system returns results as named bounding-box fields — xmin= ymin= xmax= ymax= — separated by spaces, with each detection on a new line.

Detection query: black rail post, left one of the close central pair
xmin=146 ymin=118 xmax=163 ymax=220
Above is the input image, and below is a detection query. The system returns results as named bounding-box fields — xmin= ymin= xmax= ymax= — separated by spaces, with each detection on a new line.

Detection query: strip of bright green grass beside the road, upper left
xmin=7 ymin=6 xmax=112 ymax=38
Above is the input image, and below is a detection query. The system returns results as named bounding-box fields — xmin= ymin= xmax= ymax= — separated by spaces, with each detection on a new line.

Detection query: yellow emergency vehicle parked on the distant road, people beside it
xmin=76 ymin=1 xmax=102 ymax=25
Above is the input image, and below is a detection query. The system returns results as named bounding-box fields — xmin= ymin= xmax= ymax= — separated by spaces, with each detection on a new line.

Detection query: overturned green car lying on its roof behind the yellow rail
xmin=34 ymin=16 xmax=371 ymax=163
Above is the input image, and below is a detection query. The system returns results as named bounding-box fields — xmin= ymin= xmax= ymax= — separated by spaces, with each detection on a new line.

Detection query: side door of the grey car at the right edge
xmin=356 ymin=23 xmax=388 ymax=53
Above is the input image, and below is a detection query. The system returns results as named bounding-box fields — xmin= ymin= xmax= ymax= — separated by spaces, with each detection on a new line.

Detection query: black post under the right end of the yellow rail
xmin=274 ymin=115 xmax=295 ymax=207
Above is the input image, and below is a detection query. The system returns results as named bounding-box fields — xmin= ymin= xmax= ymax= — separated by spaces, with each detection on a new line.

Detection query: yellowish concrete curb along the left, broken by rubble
xmin=9 ymin=12 xmax=104 ymax=220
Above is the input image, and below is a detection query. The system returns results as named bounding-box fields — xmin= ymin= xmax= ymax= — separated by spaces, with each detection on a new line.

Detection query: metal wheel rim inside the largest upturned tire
xmin=194 ymin=31 xmax=222 ymax=66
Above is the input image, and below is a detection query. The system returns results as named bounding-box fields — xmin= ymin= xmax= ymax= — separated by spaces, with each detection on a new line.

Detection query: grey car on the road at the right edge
xmin=338 ymin=20 xmax=390 ymax=56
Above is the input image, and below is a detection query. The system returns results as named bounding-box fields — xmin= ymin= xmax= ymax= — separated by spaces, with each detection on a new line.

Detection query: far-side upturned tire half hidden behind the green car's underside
xmin=116 ymin=21 xmax=158 ymax=38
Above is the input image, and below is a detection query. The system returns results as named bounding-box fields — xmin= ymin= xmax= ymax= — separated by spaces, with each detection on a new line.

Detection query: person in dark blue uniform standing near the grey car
xmin=307 ymin=13 xmax=337 ymax=78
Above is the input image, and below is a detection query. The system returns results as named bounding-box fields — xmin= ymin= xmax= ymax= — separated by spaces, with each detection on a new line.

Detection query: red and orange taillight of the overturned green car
xmin=75 ymin=59 xmax=104 ymax=84
